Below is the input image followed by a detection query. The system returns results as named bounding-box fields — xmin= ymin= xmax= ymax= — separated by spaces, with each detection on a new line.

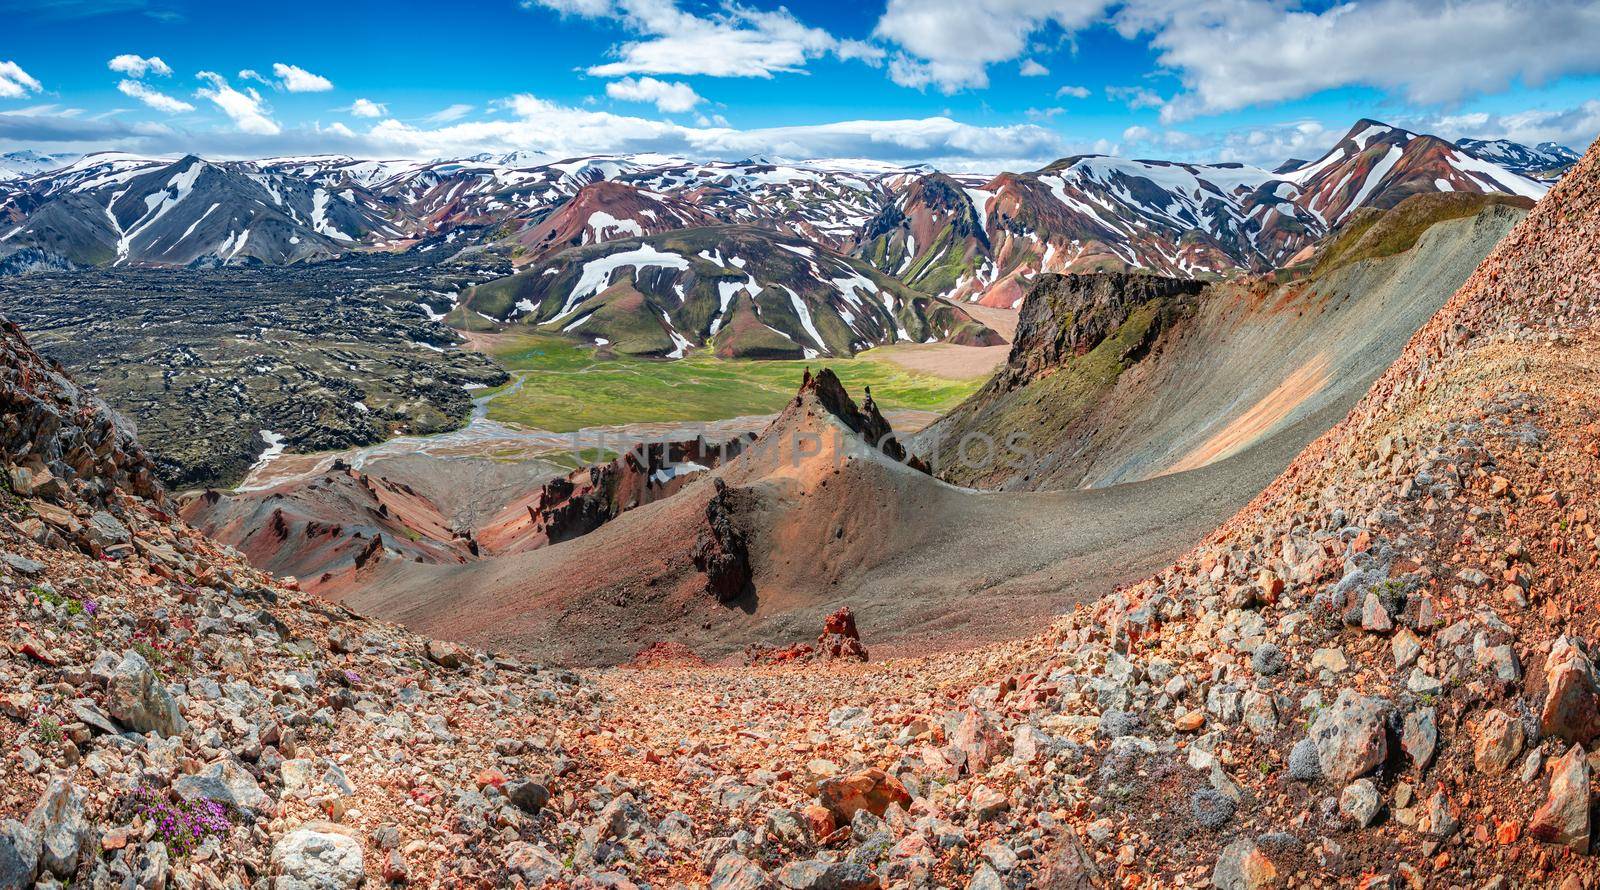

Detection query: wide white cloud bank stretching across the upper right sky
xmin=874 ymin=0 xmax=1600 ymax=123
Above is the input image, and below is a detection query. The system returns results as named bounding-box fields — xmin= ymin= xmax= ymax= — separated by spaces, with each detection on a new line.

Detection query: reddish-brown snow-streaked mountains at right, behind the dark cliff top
xmin=856 ymin=120 xmax=1547 ymax=306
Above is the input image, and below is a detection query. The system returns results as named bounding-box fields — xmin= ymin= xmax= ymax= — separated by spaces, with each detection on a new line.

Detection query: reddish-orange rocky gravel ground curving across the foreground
xmin=0 ymin=142 xmax=1600 ymax=890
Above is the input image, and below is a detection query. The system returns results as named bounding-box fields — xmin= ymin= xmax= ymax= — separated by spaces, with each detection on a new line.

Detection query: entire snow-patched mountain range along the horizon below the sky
xmin=0 ymin=120 xmax=1578 ymax=312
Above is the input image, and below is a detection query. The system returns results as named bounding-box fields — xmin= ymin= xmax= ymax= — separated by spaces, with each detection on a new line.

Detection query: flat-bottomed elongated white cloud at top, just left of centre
xmin=523 ymin=0 xmax=883 ymax=77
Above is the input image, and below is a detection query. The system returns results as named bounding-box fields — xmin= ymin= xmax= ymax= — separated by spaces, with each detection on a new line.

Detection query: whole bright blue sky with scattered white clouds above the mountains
xmin=0 ymin=0 xmax=1600 ymax=170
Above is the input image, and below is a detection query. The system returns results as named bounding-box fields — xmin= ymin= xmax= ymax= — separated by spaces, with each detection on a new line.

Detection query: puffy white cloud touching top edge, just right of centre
xmin=874 ymin=0 xmax=1106 ymax=94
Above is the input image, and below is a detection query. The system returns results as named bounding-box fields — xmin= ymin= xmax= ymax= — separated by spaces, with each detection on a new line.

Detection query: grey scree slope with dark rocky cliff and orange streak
xmin=914 ymin=195 xmax=1525 ymax=490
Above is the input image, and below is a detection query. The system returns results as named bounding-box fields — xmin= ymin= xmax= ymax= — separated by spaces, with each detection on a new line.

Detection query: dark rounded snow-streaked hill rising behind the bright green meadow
xmin=459 ymin=226 xmax=998 ymax=359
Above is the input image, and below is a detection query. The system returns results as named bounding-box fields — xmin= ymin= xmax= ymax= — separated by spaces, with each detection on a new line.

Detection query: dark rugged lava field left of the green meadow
xmin=0 ymin=250 xmax=509 ymax=488
